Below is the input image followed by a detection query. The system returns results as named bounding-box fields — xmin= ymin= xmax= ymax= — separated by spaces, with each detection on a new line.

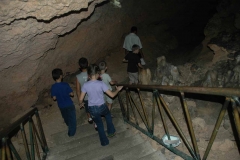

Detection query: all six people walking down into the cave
xmin=51 ymin=27 xmax=144 ymax=146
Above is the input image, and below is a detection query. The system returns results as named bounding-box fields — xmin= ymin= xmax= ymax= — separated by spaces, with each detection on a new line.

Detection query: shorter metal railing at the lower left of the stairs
xmin=0 ymin=108 xmax=49 ymax=160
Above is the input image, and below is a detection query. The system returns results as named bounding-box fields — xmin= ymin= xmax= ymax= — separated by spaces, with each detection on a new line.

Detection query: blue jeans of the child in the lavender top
xmin=88 ymin=103 xmax=116 ymax=146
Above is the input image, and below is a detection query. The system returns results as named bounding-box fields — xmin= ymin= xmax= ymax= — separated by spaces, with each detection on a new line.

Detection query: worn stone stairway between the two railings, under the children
xmin=47 ymin=110 xmax=166 ymax=160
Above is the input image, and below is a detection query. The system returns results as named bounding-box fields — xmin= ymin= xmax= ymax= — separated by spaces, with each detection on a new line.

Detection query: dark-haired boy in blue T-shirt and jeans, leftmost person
xmin=51 ymin=68 xmax=77 ymax=137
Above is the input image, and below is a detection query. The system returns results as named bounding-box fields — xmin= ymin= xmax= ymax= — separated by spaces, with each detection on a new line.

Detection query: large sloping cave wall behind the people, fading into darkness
xmin=0 ymin=0 xmax=219 ymax=124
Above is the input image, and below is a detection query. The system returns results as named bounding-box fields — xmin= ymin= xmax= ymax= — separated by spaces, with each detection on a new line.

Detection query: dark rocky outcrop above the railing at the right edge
xmin=169 ymin=0 xmax=240 ymax=87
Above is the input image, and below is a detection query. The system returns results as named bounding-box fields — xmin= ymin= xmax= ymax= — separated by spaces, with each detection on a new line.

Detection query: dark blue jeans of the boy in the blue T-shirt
xmin=59 ymin=105 xmax=77 ymax=137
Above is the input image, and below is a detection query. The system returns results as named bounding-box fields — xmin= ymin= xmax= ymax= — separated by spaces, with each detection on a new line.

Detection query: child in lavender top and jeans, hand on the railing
xmin=79 ymin=64 xmax=123 ymax=146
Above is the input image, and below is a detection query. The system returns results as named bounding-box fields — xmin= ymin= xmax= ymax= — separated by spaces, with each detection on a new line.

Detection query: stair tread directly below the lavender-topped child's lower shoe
xmin=68 ymin=134 xmax=144 ymax=160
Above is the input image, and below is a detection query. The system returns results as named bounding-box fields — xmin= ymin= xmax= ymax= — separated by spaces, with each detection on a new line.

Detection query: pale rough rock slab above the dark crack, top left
xmin=0 ymin=0 xmax=93 ymax=24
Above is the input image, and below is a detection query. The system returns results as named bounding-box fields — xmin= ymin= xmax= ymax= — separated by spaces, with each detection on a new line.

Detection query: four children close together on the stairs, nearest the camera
xmin=51 ymin=57 xmax=122 ymax=146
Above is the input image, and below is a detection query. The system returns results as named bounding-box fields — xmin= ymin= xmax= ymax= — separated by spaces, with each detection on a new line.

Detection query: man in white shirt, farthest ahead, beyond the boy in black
xmin=123 ymin=26 xmax=145 ymax=63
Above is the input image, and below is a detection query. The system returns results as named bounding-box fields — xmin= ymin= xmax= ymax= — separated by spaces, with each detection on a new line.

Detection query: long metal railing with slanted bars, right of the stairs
xmin=118 ymin=84 xmax=240 ymax=160
